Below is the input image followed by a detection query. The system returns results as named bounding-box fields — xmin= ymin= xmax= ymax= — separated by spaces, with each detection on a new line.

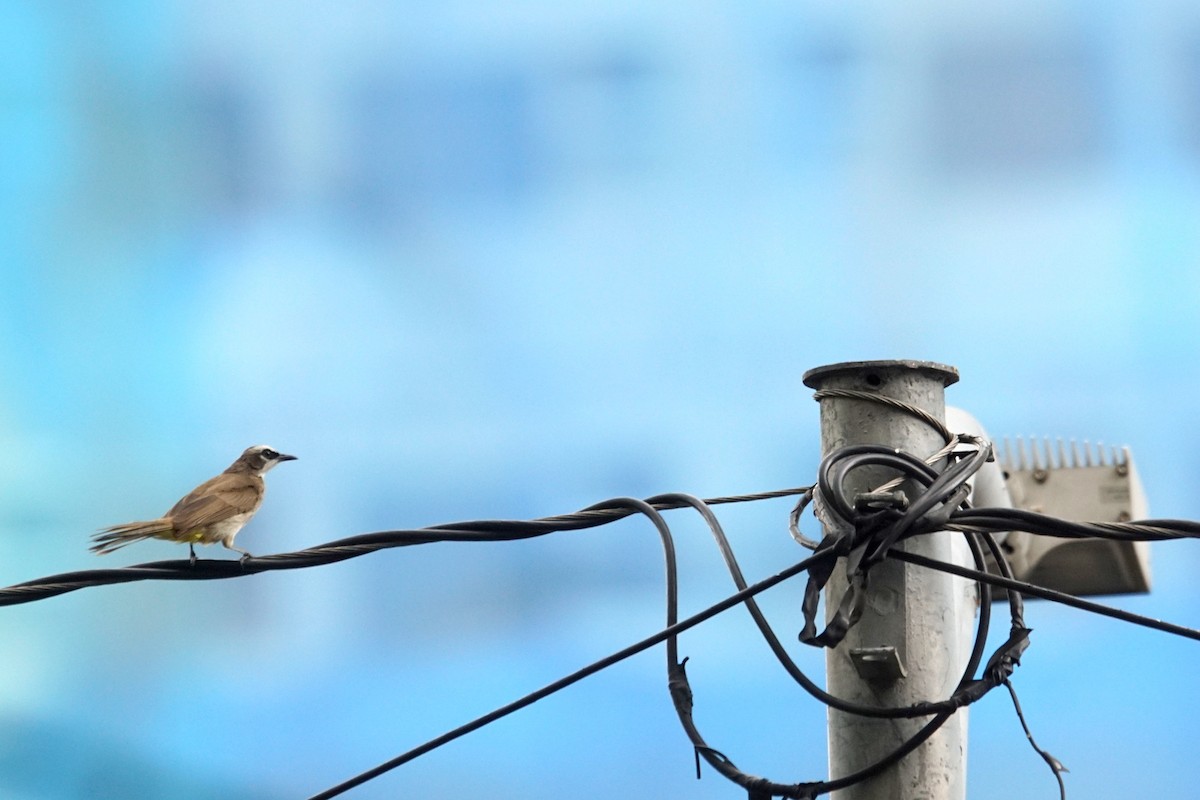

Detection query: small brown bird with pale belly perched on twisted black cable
xmin=90 ymin=445 xmax=296 ymax=565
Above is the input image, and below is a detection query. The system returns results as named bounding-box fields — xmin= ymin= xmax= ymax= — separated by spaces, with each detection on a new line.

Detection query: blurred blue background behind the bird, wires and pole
xmin=0 ymin=0 xmax=1200 ymax=800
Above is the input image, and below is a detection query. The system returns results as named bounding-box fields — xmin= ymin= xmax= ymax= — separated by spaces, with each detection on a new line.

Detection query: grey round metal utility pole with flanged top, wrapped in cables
xmin=804 ymin=361 xmax=977 ymax=800
